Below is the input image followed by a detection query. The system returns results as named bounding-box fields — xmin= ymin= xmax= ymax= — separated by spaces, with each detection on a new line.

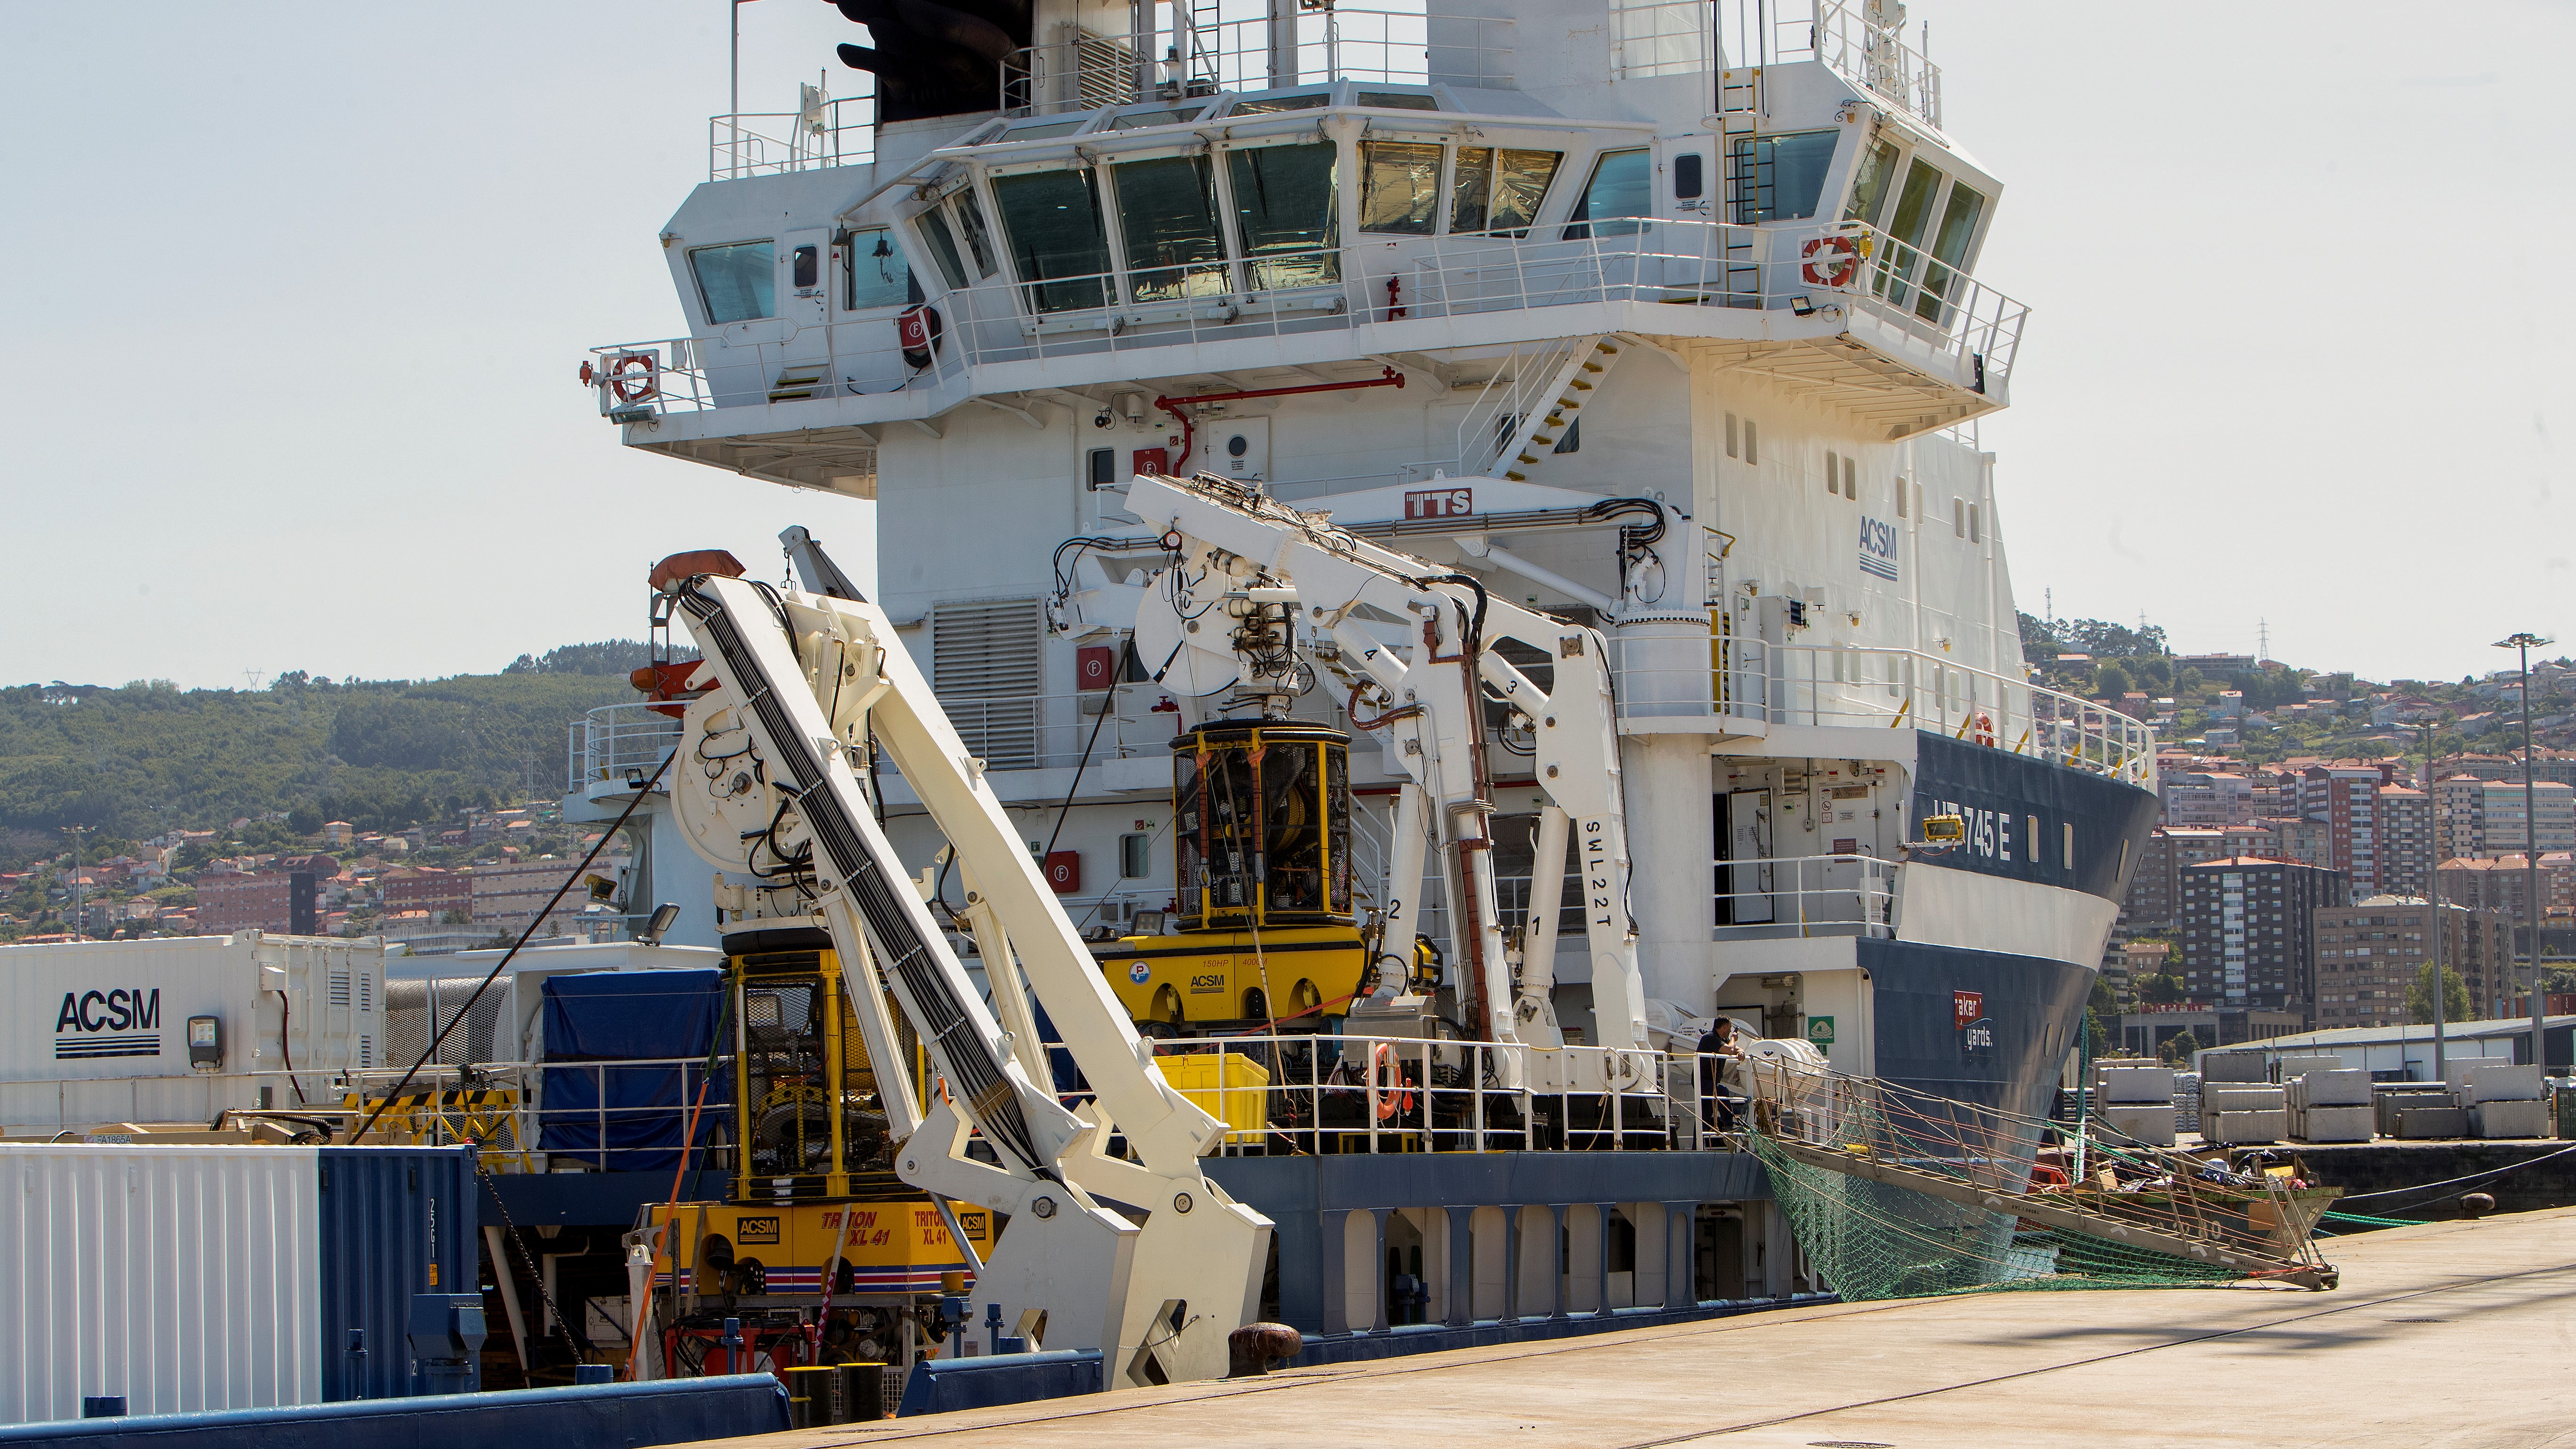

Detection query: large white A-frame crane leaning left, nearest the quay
xmin=652 ymin=539 xmax=1270 ymax=1387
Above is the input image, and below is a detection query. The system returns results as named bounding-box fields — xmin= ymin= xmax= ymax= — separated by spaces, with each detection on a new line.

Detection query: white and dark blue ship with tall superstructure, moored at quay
xmin=574 ymin=0 xmax=2156 ymax=1330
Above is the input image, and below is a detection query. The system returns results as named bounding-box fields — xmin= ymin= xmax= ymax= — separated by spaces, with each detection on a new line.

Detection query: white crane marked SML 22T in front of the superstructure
xmin=1103 ymin=475 xmax=1654 ymax=1091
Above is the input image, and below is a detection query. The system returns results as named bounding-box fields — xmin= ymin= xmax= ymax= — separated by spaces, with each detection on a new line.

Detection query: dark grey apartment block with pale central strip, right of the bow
xmin=2179 ymin=856 xmax=2352 ymax=1018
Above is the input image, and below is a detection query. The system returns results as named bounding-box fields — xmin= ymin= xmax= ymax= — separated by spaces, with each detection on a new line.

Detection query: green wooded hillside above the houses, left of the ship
xmin=0 ymin=639 xmax=646 ymax=866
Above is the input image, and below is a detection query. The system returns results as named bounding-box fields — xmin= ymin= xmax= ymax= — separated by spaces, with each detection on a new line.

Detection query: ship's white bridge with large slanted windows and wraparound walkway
xmin=585 ymin=0 xmax=2027 ymax=495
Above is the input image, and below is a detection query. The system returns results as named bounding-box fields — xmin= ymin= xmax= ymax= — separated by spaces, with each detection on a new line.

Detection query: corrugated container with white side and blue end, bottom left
xmin=0 ymin=1145 xmax=476 ymax=1423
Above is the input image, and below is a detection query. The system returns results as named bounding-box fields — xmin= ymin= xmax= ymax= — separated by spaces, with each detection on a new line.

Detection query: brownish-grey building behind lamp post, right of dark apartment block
xmin=2313 ymin=894 xmax=2514 ymax=1029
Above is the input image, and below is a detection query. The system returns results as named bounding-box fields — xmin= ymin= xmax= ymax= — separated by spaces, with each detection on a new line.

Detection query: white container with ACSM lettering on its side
xmin=0 ymin=931 xmax=384 ymax=1137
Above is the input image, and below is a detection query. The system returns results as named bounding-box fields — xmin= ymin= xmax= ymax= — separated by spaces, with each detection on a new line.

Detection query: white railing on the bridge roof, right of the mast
xmin=1610 ymin=0 xmax=1940 ymax=126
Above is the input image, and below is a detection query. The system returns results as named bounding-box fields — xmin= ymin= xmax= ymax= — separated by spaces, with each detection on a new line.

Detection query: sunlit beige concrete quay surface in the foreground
xmin=685 ymin=1209 xmax=2576 ymax=1449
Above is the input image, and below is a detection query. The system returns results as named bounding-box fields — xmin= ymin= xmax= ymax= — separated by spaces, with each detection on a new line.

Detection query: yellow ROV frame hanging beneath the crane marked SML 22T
xmin=1100 ymin=719 xmax=1368 ymax=1031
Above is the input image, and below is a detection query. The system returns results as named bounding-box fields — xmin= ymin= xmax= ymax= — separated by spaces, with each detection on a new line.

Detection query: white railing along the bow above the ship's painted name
xmin=1610 ymin=634 xmax=2156 ymax=786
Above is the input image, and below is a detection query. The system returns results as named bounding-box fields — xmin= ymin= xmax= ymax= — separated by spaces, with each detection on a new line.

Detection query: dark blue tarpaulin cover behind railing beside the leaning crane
xmin=539 ymin=969 xmax=732 ymax=1173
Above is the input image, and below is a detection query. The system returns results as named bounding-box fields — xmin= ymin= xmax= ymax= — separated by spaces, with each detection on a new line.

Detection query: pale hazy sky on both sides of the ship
xmin=0 ymin=0 xmax=2576 ymax=686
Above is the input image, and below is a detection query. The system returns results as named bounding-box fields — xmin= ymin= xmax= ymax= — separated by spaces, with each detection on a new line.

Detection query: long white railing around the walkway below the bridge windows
xmin=590 ymin=219 xmax=2027 ymax=420
